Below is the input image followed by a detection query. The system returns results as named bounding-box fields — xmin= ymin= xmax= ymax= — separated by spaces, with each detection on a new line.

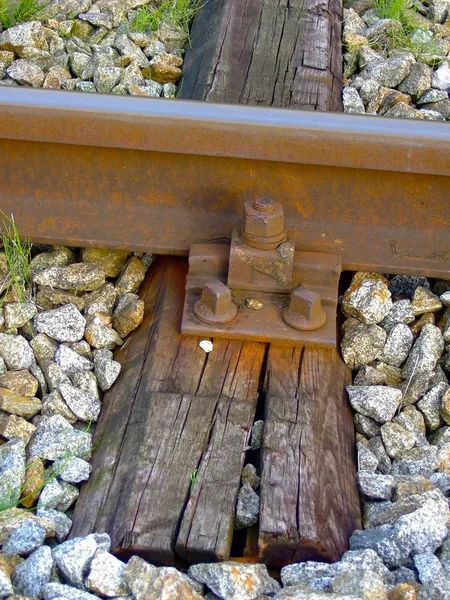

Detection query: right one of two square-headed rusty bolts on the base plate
xmin=283 ymin=286 xmax=326 ymax=331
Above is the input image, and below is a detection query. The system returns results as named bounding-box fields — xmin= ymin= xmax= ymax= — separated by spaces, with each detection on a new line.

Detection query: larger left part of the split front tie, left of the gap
xmin=71 ymin=258 xmax=265 ymax=564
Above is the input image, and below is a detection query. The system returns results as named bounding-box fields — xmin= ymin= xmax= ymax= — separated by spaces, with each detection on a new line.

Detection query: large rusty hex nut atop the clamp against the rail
xmin=241 ymin=198 xmax=286 ymax=250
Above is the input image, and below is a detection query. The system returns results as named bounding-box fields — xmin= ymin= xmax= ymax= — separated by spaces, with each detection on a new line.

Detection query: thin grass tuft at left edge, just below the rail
xmin=0 ymin=212 xmax=31 ymax=302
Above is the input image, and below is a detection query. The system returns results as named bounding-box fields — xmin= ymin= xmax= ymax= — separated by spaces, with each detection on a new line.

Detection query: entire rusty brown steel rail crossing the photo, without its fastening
xmin=0 ymin=88 xmax=450 ymax=276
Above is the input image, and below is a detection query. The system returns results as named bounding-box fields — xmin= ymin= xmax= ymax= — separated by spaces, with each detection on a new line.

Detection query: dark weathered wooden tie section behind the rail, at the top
xmin=180 ymin=0 xmax=342 ymax=111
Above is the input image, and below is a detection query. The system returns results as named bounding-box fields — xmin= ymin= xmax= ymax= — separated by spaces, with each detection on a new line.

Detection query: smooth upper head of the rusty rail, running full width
xmin=0 ymin=87 xmax=450 ymax=176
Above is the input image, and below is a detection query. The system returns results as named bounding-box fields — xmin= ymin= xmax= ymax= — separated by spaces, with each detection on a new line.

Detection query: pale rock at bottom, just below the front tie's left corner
xmin=85 ymin=550 xmax=130 ymax=598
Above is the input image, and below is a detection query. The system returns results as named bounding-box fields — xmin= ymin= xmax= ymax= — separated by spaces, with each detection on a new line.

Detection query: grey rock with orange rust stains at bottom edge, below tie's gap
xmin=188 ymin=562 xmax=280 ymax=600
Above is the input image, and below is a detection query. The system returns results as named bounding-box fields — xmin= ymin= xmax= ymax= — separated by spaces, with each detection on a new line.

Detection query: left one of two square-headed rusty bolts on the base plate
xmin=194 ymin=279 xmax=238 ymax=325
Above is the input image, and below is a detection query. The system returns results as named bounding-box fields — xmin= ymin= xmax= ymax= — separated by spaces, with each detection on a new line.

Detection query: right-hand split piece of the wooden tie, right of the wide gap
xmin=259 ymin=345 xmax=360 ymax=566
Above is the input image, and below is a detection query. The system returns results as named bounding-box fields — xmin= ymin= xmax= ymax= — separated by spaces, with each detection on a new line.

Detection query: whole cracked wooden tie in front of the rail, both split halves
xmin=71 ymin=258 xmax=360 ymax=565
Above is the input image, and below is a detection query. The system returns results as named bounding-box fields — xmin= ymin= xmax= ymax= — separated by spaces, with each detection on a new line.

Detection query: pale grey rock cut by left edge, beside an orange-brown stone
xmin=0 ymin=438 xmax=25 ymax=510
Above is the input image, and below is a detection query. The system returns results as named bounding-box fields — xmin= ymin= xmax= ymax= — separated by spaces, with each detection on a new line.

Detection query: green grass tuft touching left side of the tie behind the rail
xmin=131 ymin=0 xmax=201 ymax=35
